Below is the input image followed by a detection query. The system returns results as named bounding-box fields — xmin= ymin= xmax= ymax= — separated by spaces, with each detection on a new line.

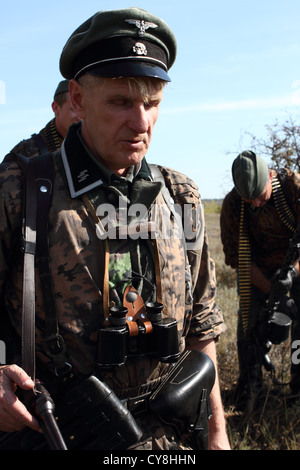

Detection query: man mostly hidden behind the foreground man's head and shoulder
xmin=4 ymin=80 xmax=78 ymax=161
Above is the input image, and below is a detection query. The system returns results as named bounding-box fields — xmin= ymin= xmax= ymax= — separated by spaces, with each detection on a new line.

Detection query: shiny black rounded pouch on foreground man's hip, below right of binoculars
xmin=149 ymin=351 xmax=215 ymax=450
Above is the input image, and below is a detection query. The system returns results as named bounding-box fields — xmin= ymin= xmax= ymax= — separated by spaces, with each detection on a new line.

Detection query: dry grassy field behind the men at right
xmin=205 ymin=206 xmax=300 ymax=450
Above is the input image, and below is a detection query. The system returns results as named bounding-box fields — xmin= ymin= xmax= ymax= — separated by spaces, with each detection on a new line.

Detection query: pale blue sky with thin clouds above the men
xmin=0 ymin=0 xmax=300 ymax=198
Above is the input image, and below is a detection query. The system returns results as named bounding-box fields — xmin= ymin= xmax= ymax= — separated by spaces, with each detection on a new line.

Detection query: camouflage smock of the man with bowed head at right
xmin=220 ymin=169 xmax=300 ymax=276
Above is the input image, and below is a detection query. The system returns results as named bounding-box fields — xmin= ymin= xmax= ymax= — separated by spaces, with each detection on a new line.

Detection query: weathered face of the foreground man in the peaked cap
xmin=70 ymin=78 xmax=163 ymax=175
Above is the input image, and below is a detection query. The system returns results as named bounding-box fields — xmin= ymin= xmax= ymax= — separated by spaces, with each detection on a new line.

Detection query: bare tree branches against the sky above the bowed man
xmin=249 ymin=116 xmax=300 ymax=172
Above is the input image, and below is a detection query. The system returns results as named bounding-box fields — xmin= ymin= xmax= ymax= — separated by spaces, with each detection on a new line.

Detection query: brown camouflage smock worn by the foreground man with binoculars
xmin=0 ymin=126 xmax=225 ymax=448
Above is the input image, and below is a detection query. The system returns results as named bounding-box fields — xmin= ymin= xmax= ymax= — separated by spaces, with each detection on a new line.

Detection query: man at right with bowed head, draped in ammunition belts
xmin=221 ymin=150 xmax=300 ymax=411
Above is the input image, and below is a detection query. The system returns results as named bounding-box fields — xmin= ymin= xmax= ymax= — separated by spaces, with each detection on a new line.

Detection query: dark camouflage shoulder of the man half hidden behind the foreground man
xmin=3 ymin=118 xmax=63 ymax=161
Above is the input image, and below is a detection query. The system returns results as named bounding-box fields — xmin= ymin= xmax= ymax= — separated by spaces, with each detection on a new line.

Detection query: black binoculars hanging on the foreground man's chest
xmin=97 ymin=302 xmax=180 ymax=367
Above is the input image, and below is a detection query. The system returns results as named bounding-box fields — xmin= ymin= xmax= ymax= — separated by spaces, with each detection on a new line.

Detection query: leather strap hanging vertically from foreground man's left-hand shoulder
xmin=17 ymin=154 xmax=54 ymax=380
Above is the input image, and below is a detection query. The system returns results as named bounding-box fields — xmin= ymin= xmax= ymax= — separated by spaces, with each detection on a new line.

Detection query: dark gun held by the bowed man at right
xmin=258 ymin=223 xmax=300 ymax=381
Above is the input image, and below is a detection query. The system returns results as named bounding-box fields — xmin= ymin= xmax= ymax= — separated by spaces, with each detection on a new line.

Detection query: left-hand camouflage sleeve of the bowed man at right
xmin=220 ymin=189 xmax=241 ymax=269
